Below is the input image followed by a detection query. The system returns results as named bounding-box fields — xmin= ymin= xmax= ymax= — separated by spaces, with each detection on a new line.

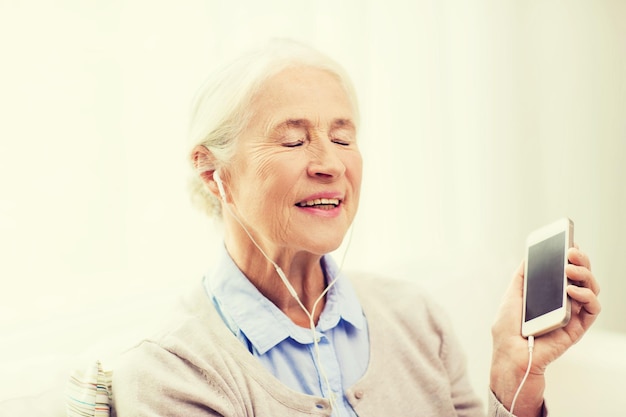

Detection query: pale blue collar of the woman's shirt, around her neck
xmin=204 ymin=247 xmax=365 ymax=354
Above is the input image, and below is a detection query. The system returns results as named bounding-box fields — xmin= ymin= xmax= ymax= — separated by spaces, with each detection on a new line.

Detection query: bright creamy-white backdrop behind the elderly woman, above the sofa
xmin=0 ymin=0 xmax=626 ymax=412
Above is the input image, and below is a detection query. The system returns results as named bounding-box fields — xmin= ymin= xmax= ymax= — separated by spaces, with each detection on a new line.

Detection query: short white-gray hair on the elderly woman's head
xmin=189 ymin=39 xmax=359 ymax=217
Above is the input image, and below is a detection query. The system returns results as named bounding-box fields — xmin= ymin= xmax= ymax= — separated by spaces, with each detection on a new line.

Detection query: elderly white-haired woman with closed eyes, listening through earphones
xmin=113 ymin=41 xmax=600 ymax=417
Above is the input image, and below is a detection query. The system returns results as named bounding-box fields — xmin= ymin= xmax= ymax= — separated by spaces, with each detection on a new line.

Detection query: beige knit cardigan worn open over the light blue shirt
xmin=112 ymin=275 xmax=510 ymax=417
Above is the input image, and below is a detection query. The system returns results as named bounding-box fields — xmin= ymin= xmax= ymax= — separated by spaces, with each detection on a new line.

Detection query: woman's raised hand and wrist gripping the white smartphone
xmin=490 ymin=247 xmax=601 ymax=417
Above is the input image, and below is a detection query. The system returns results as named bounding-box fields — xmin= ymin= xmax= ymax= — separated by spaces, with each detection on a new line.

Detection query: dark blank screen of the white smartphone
xmin=525 ymin=232 xmax=566 ymax=321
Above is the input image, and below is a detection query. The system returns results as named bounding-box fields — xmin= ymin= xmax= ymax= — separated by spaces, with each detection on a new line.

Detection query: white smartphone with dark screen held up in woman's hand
xmin=522 ymin=218 xmax=574 ymax=337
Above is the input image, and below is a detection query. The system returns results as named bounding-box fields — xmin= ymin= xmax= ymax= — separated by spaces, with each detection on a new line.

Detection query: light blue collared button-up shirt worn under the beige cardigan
xmin=204 ymin=248 xmax=369 ymax=417
